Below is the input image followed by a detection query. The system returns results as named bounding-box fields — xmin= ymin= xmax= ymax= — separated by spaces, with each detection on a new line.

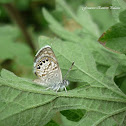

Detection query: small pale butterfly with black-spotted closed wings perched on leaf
xmin=34 ymin=45 xmax=74 ymax=92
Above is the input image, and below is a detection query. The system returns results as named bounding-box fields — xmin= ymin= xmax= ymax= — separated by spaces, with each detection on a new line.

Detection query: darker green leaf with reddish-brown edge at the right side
xmin=99 ymin=10 xmax=126 ymax=54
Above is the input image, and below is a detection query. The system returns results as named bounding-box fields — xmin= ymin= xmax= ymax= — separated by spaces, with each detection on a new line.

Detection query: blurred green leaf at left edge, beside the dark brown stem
xmin=0 ymin=26 xmax=33 ymax=66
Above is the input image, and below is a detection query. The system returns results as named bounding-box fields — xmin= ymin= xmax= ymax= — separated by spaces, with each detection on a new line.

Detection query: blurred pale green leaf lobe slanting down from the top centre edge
xmin=56 ymin=0 xmax=99 ymax=37
